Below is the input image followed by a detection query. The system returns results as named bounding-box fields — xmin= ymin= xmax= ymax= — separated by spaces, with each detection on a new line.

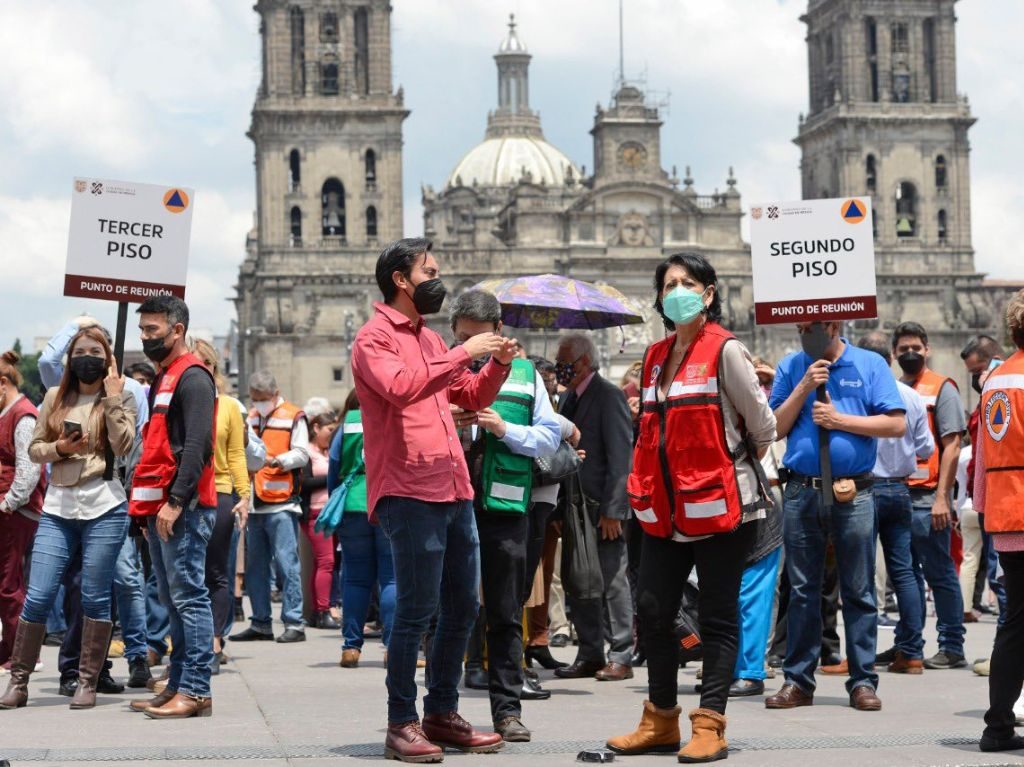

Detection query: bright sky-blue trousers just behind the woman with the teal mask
xmin=732 ymin=546 xmax=782 ymax=679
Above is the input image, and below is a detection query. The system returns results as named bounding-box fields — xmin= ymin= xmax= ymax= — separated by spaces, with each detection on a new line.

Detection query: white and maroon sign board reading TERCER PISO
xmin=65 ymin=178 xmax=195 ymax=303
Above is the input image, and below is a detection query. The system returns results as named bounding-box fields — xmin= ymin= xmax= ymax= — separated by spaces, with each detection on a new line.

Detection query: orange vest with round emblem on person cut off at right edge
xmin=978 ymin=351 xmax=1024 ymax=532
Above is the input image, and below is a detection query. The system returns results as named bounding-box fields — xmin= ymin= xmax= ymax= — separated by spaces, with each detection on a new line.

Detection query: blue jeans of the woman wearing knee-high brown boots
xmin=22 ymin=504 xmax=128 ymax=624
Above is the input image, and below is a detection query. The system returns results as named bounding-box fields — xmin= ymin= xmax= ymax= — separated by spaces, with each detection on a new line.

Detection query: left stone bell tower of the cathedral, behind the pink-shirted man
xmin=236 ymin=0 xmax=409 ymax=404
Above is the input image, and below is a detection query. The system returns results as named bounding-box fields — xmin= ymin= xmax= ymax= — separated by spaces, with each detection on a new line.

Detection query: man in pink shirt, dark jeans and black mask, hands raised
xmin=352 ymin=239 xmax=515 ymax=762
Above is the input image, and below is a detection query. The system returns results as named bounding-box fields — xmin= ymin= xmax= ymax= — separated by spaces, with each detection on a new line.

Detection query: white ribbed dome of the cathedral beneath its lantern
xmin=449 ymin=135 xmax=581 ymax=186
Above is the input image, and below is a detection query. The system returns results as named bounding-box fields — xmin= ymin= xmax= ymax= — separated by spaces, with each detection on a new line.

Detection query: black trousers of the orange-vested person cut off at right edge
xmin=985 ymin=551 xmax=1024 ymax=739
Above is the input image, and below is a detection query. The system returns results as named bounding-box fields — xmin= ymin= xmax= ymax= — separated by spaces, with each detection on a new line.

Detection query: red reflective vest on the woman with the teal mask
xmin=627 ymin=323 xmax=757 ymax=538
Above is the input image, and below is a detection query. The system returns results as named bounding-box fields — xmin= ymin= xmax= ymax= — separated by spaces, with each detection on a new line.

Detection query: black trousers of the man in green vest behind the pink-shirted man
xmin=476 ymin=511 xmax=529 ymax=722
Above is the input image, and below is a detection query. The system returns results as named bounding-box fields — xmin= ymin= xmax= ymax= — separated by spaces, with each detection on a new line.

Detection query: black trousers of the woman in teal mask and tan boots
xmin=637 ymin=524 xmax=755 ymax=714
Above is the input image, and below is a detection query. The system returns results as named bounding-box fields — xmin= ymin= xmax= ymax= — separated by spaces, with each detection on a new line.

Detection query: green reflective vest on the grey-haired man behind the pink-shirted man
xmin=481 ymin=358 xmax=537 ymax=514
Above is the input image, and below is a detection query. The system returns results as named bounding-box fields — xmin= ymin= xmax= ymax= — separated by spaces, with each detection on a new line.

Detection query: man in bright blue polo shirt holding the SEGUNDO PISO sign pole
xmin=765 ymin=323 xmax=906 ymax=711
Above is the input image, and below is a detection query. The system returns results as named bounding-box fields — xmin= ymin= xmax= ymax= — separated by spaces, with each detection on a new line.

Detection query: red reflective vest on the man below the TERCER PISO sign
xmin=128 ymin=353 xmax=217 ymax=517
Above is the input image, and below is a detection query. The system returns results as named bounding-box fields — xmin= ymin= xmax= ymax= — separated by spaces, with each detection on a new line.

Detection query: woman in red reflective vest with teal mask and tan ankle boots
xmin=608 ymin=253 xmax=775 ymax=763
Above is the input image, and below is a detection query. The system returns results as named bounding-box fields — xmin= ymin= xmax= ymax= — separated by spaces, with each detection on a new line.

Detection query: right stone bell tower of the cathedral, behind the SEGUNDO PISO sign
xmin=796 ymin=0 xmax=1000 ymax=380
